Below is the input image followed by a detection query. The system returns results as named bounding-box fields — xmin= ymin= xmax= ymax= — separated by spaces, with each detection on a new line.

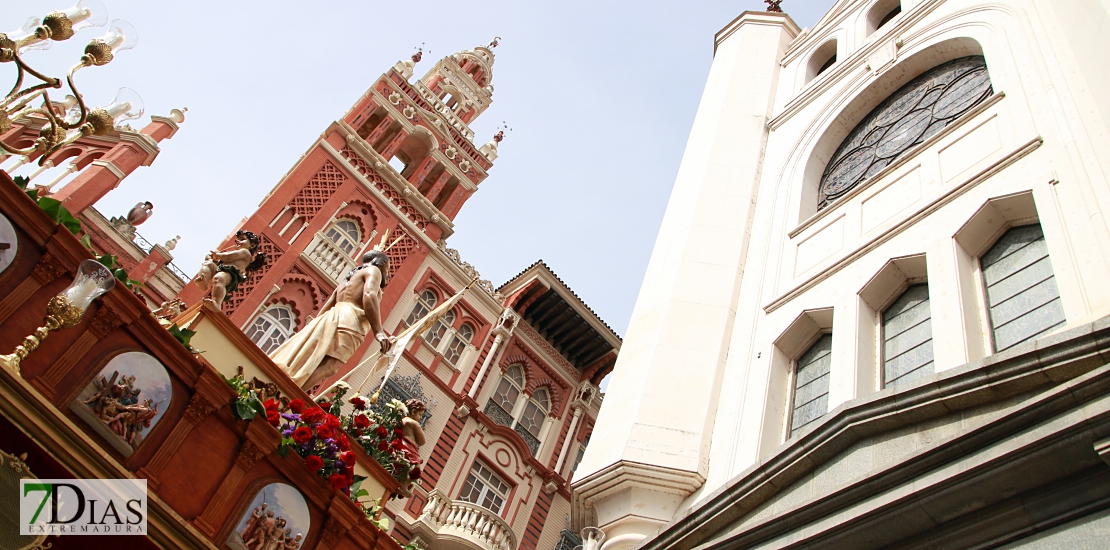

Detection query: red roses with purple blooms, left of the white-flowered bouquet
xmin=279 ymin=389 xmax=355 ymax=494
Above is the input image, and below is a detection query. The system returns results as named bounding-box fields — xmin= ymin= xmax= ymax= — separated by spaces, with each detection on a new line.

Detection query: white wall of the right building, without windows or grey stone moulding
xmin=575 ymin=0 xmax=1110 ymax=548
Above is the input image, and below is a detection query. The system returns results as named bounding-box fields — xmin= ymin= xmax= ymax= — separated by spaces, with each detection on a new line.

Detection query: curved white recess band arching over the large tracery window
xmin=798 ymin=37 xmax=989 ymax=222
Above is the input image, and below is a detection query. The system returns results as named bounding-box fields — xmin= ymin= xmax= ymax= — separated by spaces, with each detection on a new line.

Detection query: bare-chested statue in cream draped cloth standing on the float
xmin=270 ymin=238 xmax=392 ymax=391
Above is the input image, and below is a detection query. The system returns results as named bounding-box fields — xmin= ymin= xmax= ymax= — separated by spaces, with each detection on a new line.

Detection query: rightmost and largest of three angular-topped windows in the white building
xmin=979 ymin=223 xmax=1067 ymax=352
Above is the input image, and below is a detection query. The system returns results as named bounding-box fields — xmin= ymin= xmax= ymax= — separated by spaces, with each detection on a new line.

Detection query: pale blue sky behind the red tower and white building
xmin=8 ymin=0 xmax=833 ymax=336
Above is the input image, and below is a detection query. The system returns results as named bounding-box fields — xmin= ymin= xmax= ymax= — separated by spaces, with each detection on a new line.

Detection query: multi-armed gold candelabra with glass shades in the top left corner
xmin=0 ymin=0 xmax=138 ymax=166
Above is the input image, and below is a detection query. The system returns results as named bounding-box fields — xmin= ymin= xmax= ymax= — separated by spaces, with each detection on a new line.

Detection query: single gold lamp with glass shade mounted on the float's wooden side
xmin=0 ymin=260 xmax=115 ymax=374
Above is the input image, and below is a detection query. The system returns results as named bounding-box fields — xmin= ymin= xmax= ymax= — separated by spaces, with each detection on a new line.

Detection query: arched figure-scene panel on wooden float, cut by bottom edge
xmin=226 ymin=483 xmax=312 ymax=550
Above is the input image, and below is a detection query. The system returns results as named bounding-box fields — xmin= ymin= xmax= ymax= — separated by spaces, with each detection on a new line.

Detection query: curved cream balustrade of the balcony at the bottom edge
xmin=417 ymin=489 xmax=516 ymax=550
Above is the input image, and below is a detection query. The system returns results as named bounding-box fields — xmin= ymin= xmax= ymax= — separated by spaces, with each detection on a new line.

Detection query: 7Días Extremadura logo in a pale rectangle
xmin=19 ymin=479 xmax=147 ymax=536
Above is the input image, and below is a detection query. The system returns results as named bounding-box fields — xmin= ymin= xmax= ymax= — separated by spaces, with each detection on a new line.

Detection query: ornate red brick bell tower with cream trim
xmin=180 ymin=40 xmax=501 ymax=367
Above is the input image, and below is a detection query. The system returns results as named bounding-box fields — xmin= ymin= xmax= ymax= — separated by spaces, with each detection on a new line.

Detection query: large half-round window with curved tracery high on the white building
xmin=817 ymin=56 xmax=995 ymax=210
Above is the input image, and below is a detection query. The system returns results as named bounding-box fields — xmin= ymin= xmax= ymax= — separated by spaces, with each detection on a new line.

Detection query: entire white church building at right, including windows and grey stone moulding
xmin=574 ymin=0 xmax=1110 ymax=550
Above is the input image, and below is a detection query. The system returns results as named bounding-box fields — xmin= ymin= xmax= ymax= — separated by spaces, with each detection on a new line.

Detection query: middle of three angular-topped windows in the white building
xmin=882 ymin=283 xmax=932 ymax=386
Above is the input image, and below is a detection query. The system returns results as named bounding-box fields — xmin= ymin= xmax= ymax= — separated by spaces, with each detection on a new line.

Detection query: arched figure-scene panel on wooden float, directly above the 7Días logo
xmin=70 ymin=351 xmax=173 ymax=457
